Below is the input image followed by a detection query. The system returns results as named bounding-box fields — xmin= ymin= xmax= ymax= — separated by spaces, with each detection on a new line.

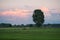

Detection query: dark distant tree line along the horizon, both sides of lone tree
xmin=0 ymin=23 xmax=60 ymax=28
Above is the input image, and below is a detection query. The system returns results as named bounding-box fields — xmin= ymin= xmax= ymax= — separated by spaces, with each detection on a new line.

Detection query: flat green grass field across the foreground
xmin=0 ymin=28 xmax=60 ymax=40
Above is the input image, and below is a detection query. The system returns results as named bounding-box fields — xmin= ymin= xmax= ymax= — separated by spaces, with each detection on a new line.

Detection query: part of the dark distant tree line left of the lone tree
xmin=0 ymin=23 xmax=35 ymax=28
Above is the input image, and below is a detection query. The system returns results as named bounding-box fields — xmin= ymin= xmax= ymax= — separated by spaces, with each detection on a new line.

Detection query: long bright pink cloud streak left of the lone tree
xmin=0 ymin=9 xmax=30 ymax=18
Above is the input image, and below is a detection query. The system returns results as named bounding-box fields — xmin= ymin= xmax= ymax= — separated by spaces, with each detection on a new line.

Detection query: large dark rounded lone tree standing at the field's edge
xmin=32 ymin=9 xmax=44 ymax=27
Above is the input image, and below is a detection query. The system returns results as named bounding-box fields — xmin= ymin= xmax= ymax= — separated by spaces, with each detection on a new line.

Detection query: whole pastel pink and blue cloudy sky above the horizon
xmin=0 ymin=0 xmax=60 ymax=24
